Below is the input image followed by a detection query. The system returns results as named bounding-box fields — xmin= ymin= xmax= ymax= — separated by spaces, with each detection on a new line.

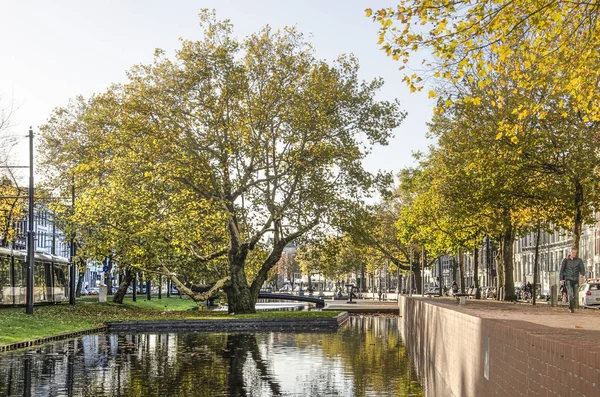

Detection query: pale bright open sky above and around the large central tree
xmin=0 ymin=0 xmax=434 ymax=179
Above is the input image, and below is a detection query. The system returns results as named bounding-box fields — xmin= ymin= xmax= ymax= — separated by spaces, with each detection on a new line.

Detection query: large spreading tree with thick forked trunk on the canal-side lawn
xmin=38 ymin=12 xmax=403 ymax=313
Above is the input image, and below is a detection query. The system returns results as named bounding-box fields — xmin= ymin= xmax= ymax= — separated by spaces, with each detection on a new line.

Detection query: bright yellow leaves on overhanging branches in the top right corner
xmin=365 ymin=0 xmax=600 ymax=141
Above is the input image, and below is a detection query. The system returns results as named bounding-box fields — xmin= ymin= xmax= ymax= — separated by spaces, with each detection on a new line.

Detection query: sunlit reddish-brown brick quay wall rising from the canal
xmin=398 ymin=296 xmax=600 ymax=397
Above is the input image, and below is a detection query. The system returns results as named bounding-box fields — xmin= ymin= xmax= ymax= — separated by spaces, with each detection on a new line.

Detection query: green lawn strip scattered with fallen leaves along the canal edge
xmin=0 ymin=297 xmax=339 ymax=345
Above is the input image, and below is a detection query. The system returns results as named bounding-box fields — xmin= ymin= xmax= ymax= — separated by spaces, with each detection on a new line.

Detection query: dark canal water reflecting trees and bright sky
xmin=0 ymin=317 xmax=424 ymax=397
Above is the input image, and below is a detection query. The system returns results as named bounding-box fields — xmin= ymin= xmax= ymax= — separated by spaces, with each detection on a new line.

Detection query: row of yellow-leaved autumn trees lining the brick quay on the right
xmin=367 ymin=0 xmax=600 ymax=300
